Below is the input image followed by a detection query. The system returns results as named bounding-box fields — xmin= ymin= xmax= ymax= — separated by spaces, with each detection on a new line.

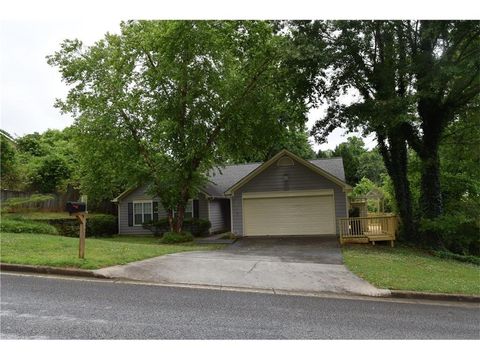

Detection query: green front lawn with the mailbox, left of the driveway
xmin=0 ymin=233 xmax=223 ymax=269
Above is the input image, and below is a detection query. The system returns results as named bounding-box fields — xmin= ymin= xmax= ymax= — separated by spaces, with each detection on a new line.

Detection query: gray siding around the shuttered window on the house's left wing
xmin=118 ymin=185 xmax=208 ymax=235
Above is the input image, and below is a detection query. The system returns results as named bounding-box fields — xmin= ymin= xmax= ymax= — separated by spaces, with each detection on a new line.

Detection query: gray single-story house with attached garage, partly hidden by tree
xmin=113 ymin=150 xmax=351 ymax=236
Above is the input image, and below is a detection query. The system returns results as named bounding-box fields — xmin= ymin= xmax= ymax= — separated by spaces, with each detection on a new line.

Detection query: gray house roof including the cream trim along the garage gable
xmin=112 ymin=150 xmax=351 ymax=202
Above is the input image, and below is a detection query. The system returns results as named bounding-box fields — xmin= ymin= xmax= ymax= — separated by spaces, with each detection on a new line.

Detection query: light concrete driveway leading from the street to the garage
xmin=96 ymin=237 xmax=389 ymax=296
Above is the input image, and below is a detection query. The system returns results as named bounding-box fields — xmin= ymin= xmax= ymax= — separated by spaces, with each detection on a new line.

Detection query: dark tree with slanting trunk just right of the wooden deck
xmin=292 ymin=21 xmax=416 ymax=241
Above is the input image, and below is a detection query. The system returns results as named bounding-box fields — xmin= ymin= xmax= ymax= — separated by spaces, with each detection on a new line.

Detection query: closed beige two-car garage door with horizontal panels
xmin=243 ymin=192 xmax=335 ymax=236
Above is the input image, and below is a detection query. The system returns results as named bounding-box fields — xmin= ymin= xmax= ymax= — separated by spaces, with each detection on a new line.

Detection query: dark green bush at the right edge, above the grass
xmin=420 ymin=215 xmax=480 ymax=256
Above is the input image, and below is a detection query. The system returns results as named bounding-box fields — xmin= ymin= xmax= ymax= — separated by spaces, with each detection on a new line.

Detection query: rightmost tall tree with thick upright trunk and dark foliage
xmin=404 ymin=21 xmax=480 ymax=222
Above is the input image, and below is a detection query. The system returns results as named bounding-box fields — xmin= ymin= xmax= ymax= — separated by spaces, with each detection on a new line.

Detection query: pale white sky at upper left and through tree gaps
xmin=0 ymin=19 xmax=375 ymax=151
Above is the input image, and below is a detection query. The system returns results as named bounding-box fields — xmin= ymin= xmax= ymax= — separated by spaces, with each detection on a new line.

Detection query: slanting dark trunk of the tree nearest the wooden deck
xmin=378 ymin=132 xmax=418 ymax=242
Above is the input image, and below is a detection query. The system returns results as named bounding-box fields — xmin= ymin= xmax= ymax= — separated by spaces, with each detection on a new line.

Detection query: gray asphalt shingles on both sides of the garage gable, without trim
xmin=205 ymin=158 xmax=345 ymax=197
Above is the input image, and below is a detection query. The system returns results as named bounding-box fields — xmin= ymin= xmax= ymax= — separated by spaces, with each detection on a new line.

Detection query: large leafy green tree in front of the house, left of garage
xmin=48 ymin=21 xmax=306 ymax=232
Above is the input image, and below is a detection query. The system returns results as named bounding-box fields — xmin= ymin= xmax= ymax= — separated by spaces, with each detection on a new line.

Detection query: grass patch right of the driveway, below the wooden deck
xmin=342 ymin=245 xmax=480 ymax=295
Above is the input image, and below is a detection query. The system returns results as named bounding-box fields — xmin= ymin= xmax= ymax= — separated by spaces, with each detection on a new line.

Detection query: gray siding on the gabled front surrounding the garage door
xmin=232 ymin=158 xmax=347 ymax=236
